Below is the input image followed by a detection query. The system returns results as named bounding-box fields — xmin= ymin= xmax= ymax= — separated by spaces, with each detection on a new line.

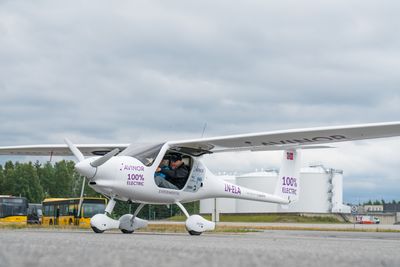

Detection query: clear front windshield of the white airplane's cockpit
xmin=120 ymin=144 xmax=164 ymax=167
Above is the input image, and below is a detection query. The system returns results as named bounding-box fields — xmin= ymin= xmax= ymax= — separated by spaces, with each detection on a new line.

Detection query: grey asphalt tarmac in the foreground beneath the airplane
xmin=0 ymin=229 xmax=400 ymax=267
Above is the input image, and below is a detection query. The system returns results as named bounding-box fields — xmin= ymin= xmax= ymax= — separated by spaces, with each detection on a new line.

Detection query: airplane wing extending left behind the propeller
xmin=0 ymin=144 xmax=128 ymax=156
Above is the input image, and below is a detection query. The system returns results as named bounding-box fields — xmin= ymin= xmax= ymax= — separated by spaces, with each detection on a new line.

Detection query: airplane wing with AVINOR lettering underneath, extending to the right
xmin=168 ymin=122 xmax=400 ymax=155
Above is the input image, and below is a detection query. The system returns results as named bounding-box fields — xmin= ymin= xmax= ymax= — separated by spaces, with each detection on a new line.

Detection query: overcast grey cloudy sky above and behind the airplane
xmin=0 ymin=0 xmax=400 ymax=202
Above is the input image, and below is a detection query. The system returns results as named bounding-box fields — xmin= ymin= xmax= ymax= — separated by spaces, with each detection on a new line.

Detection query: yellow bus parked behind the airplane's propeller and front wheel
xmin=42 ymin=197 xmax=107 ymax=227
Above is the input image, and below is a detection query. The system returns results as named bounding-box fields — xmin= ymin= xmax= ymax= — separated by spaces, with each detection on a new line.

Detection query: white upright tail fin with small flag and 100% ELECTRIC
xmin=275 ymin=149 xmax=301 ymax=203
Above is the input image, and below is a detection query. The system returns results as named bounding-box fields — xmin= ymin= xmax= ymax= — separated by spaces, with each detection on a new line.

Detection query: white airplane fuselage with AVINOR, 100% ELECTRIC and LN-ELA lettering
xmin=89 ymin=156 xmax=286 ymax=204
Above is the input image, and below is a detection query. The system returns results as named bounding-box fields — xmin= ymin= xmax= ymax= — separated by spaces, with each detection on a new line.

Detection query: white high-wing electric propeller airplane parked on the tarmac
xmin=0 ymin=122 xmax=400 ymax=235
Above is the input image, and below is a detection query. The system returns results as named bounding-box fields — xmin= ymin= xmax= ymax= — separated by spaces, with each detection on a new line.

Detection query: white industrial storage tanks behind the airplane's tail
xmin=200 ymin=165 xmax=351 ymax=214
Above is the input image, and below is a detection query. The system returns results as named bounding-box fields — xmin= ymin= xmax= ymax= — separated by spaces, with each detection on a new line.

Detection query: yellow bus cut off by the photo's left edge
xmin=0 ymin=195 xmax=28 ymax=224
